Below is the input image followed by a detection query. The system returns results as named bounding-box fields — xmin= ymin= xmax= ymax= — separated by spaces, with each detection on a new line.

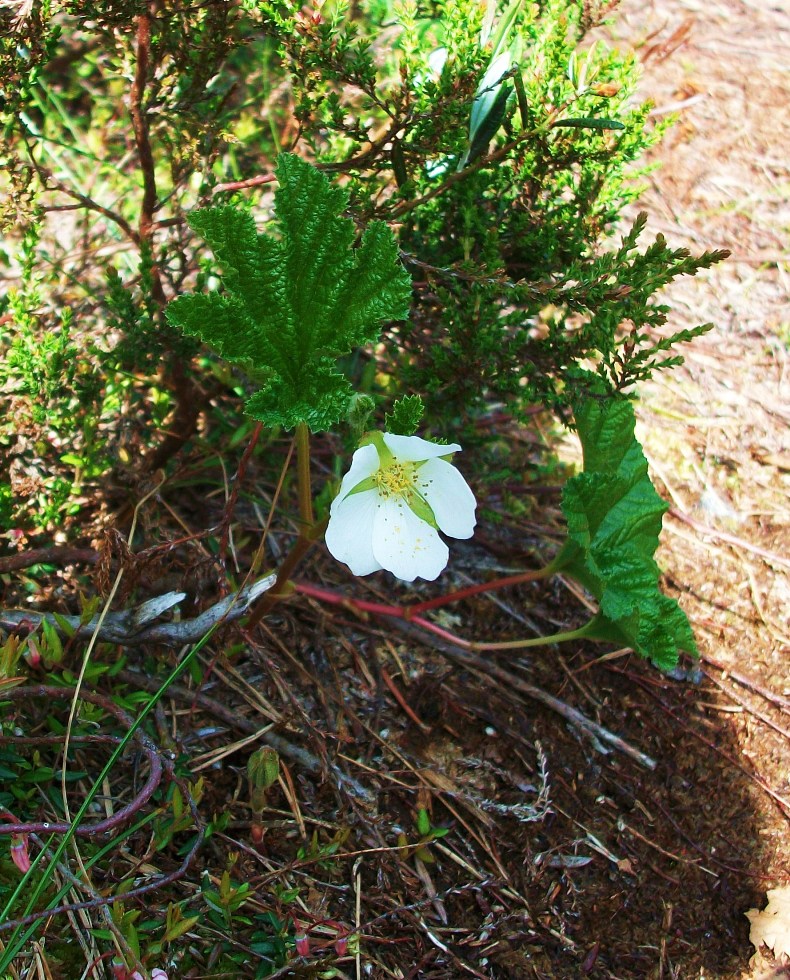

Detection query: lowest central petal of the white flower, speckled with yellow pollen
xmin=372 ymin=494 xmax=450 ymax=582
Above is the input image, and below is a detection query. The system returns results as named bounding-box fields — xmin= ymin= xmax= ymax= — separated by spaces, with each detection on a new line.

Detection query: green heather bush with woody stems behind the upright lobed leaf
xmin=0 ymin=0 xmax=720 ymax=526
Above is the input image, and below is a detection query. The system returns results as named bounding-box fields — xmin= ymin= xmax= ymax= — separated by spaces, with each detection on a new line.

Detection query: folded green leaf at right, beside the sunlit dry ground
xmin=552 ymin=399 xmax=697 ymax=669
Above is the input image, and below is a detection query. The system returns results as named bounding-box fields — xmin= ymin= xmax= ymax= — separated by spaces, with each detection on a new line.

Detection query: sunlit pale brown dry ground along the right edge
xmin=610 ymin=0 xmax=790 ymax=975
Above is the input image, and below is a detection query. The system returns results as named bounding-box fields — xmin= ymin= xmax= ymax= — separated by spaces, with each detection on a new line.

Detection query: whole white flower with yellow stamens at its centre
xmin=326 ymin=432 xmax=477 ymax=582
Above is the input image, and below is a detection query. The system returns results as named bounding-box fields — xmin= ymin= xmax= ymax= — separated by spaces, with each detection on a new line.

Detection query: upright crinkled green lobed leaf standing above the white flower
xmin=167 ymin=153 xmax=411 ymax=431
